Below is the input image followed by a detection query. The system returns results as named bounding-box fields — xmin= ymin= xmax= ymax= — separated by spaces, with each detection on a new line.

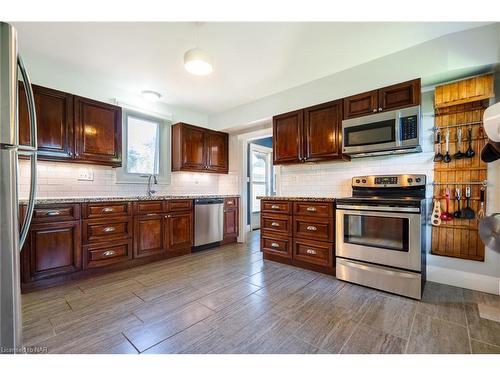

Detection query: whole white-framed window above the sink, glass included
xmin=116 ymin=110 xmax=170 ymax=184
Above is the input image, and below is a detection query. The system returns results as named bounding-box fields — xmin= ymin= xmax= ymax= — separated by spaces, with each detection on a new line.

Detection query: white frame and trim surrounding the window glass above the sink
xmin=115 ymin=108 xmax=171 ymax=185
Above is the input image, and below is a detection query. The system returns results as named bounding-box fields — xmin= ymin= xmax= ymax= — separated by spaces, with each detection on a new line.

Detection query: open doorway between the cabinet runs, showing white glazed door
xmin=247 ymin=137 xmax=276 ymax=230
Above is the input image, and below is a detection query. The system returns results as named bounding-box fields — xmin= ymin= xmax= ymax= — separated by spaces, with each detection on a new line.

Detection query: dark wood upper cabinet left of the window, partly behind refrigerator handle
xmin=19 ymin=83 xmax=122 ymax=167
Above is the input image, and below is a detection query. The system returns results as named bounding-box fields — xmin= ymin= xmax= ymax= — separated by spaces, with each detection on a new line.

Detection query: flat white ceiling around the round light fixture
xmin=15 ymin=22 xmax=485 ymax=114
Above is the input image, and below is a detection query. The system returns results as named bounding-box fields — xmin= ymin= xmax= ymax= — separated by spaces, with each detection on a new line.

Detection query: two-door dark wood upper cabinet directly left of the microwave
xmin=273 ymin=100 xmax=348 ymax=164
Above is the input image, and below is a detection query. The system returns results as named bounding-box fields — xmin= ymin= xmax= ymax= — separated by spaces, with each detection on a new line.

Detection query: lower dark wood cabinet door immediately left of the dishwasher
xmin=165 ymin=212 xmax=193 ymax=250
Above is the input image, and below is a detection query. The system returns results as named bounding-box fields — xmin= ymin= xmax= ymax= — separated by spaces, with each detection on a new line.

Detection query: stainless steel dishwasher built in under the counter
xmin=193 ymin=198 xmax=224 ymax=251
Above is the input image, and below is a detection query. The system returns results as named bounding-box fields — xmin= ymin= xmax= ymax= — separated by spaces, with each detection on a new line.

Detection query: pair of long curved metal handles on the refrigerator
xmin=17 ymin=56 xmax=38 ymax=250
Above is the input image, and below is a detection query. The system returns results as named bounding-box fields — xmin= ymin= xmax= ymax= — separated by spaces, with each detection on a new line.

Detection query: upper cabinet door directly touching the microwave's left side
xmin=304 ymin=100 xmax=342 ymax=161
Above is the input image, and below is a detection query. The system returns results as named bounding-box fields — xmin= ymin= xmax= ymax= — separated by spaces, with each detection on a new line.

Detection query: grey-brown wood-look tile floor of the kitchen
xmin=22 ymin=232 xmax=500 ymax=353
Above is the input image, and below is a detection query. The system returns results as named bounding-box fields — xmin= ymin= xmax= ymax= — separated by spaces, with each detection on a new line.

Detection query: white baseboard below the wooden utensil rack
xmin=427 ymin=265 xmax=500 ymax=295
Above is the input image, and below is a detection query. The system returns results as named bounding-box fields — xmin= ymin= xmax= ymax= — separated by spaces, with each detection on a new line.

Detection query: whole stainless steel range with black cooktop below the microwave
xmin=336 ymin=174 xmax=426 ymax=299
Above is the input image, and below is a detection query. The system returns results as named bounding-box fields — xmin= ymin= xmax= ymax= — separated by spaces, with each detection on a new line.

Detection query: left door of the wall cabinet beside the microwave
xmin=273 ymin=110 xmax=304 ymax=164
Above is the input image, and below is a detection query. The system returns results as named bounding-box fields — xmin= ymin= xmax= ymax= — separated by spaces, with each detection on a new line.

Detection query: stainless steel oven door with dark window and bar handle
xmin=336 ymin=205 xmax=421 ymax=271
